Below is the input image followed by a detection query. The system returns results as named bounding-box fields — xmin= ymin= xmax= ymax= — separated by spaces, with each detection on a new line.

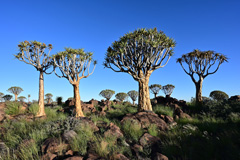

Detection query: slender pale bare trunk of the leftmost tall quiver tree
xmin=36 ymin=71 xmax=46 ymax=117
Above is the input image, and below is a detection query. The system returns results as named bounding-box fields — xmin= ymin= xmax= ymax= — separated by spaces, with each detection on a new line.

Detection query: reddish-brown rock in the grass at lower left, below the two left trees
xmin=42 ymin=138 xmax=69 ymax=154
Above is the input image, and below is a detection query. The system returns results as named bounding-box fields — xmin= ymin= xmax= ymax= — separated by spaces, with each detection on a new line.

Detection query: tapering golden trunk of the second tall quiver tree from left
xmin=73 ymin=84 xmax=85 ymax=117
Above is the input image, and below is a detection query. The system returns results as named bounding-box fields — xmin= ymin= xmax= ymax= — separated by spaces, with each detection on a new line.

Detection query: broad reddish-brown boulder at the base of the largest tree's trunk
xmin=121 ymin=112 xmax=168 ymax=131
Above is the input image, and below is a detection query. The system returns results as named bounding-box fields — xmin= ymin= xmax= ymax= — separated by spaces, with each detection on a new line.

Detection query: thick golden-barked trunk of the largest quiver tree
xmin=138 ymin=71 xmax=152 ymax=112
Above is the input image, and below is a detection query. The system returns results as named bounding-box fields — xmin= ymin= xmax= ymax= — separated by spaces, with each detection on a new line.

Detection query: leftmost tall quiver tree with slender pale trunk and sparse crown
xmin=15 ymin=41 xmax=52 ymax=117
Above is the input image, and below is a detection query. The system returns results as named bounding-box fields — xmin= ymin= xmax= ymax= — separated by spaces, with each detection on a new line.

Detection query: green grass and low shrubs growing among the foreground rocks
xmin=0 ymin=100 xmax=240 ymax=160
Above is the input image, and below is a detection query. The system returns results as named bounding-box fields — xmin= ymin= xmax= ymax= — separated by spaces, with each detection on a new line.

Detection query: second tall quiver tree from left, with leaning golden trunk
xmin=53 ymin=48 xmax=97 ymax=117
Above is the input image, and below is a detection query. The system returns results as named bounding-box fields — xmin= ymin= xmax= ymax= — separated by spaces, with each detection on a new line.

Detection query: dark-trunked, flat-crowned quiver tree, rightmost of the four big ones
xmin=177 ymin=49 xmax=227 ymax=104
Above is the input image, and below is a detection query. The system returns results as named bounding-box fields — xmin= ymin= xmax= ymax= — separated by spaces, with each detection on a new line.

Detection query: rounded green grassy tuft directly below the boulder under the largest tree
xmin=122 ymin=120 xmax=143 ymax=142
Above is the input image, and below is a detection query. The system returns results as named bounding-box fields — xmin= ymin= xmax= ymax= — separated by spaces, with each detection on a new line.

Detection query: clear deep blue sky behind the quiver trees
xmin=0 ymin=0 xmax=240 ymax=101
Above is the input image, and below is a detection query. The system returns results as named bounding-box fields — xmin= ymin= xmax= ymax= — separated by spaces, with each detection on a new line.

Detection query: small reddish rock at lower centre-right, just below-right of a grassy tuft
xmin=139 ymin=133 xmax=160 ymax=147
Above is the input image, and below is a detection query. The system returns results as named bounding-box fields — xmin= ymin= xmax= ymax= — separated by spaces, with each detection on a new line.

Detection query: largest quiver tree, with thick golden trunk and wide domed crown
xmin=104 ymin=28 xmax=175 ymax=111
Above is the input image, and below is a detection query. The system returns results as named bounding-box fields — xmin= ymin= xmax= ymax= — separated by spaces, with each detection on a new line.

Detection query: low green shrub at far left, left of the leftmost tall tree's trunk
xmin=5 ymin=102 xmax=24 ymax=115
